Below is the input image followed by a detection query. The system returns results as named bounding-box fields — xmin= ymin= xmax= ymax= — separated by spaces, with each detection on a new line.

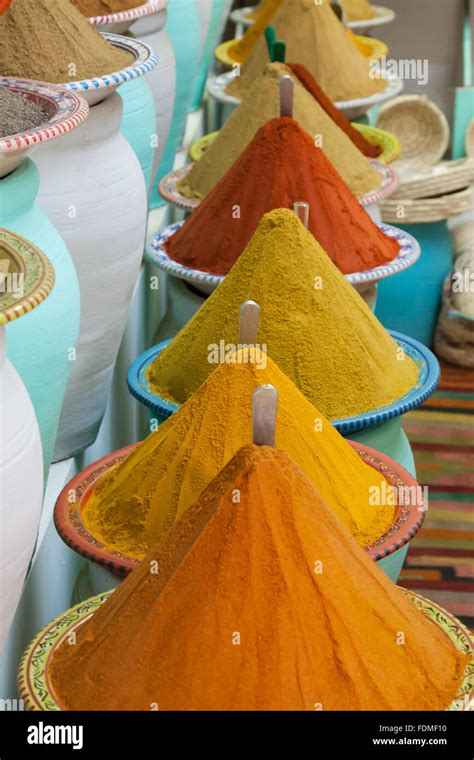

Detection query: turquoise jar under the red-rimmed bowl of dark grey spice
xmin=0 ymin=159 xmax=80 ymax=482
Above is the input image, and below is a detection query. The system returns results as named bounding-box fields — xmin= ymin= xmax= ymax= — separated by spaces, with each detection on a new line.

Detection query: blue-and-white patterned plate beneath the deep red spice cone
xmin=145 ymin=222 xmax=420 ymax=293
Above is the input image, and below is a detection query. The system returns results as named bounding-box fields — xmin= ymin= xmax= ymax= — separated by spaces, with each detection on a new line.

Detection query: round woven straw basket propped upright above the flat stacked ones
xmin=377 ymin=95 xmax=449 ymax=165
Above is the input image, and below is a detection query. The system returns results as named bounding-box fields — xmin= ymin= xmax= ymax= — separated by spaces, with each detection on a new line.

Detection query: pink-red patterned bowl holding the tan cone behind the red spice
xmin=158 ymin=159 xmax=400 ymax=211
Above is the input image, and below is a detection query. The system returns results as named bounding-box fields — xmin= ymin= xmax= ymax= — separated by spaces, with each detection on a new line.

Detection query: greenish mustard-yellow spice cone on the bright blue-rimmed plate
xmin=148 ymin=209 xmax=418 ymax=419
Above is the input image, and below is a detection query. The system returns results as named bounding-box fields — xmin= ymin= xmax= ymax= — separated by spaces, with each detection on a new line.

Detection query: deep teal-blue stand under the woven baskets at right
xmin=375 ymin=221 xmax=452 ymax=346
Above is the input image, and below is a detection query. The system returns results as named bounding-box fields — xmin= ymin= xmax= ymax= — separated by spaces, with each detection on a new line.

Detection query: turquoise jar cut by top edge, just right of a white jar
xmin=150 ymin=0 xmax=201 ymax=208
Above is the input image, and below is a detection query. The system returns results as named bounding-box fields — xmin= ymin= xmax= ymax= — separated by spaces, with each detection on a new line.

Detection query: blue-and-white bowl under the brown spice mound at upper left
xmin=63 ymin=32 xmax=158 ymax=106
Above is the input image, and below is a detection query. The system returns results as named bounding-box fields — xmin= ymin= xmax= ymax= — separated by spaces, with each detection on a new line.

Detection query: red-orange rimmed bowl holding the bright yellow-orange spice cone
xmin=54 ymin=441 xmax=428 ymax=578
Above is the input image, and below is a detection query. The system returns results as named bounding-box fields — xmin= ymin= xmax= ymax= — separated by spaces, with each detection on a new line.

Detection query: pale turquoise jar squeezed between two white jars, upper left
xmin=117 ymin=77 xmax=157 ymax=188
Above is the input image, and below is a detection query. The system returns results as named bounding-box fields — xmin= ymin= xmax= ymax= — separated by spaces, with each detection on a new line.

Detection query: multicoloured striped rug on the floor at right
xmin=400 ymin=364 xmax=474 ymax=629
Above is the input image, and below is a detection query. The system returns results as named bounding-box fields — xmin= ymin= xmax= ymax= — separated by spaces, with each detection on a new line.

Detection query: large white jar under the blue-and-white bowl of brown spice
xmin=37 ymin=93 xmax=147 ymax=461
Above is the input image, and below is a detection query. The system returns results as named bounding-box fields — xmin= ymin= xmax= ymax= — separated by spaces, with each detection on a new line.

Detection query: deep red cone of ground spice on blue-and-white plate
xmin=169 ymin=117 xmax=399 ymax=275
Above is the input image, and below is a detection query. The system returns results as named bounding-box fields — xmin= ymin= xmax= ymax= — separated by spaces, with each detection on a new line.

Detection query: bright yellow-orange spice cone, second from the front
xmin=83 ymin=348 xmax=394 ymax=559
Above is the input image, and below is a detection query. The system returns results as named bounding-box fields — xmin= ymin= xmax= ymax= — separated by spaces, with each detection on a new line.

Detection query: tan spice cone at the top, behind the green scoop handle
xmin=227 ymin=0 xmax=387 ymax=102
